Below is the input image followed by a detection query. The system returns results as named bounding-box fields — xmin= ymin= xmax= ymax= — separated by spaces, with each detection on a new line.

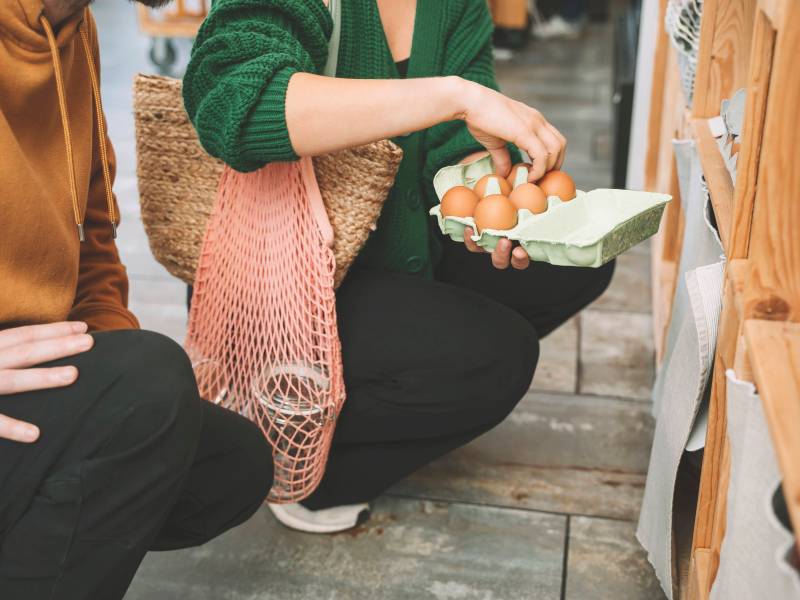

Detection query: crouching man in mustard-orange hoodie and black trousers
xmin=0 ymin=0 xmax=272 ymax=600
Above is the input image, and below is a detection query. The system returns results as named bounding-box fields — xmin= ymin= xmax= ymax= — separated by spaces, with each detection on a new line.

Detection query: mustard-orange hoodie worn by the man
xmin=0 ymin=0 xmax=138 ymax=330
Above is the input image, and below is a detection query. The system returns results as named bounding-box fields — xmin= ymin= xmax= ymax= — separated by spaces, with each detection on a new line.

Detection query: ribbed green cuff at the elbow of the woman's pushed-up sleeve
xmin=240 ymin=67 xmax=299 ymax=168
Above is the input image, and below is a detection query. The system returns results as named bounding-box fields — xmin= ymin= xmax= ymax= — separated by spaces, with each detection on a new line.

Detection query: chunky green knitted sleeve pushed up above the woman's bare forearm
xmin=183 ymin=0 xmax=333 ymax=171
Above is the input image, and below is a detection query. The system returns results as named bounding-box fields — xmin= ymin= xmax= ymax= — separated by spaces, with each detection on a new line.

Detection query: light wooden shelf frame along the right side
xmin=645 ymin=0 xmax=800 ymax=600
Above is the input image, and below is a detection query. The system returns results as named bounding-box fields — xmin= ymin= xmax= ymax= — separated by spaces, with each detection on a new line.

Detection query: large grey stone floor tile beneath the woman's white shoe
xmin=126 ymin=498 xmax=566 ymax=600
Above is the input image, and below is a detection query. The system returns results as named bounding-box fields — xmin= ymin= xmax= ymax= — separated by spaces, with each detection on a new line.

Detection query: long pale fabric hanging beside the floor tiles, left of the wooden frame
xmin=636 ymin=140 xmax=724 ymax=598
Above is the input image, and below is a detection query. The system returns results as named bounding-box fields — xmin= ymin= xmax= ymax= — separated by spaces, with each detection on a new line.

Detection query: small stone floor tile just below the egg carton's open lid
xmin=592 ymin=249 xmax=652 ymax=313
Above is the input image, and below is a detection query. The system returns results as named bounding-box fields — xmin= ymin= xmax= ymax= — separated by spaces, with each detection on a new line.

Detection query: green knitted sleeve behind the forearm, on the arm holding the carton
xmin=423 ymin=0 xmax=520 ymax=195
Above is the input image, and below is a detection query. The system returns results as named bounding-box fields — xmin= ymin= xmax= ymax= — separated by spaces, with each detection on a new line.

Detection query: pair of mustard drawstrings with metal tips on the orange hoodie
xmin=39 ymin=9 xmax=117 ymax=242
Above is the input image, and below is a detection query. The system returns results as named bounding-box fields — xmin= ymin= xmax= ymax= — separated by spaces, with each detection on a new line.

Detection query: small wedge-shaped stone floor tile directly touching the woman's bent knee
xmin=531 ymin=319 xmax=578 ymax=393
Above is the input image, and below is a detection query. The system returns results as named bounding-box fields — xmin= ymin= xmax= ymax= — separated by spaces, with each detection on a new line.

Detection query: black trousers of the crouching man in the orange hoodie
xmin=0 ymin=331 xmax=272 ymax=600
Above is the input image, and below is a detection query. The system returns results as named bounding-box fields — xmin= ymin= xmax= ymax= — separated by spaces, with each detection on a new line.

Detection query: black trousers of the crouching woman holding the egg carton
xmin=303 ymin=240 xmax=614 ymax=509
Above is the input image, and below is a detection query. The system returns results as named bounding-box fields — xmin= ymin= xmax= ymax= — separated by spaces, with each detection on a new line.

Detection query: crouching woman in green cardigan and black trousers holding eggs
xmin=184 ymin=0 xmax=613 ymax=532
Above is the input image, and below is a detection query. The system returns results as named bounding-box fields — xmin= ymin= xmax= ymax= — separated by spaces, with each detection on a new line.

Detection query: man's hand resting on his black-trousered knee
xmin=0 ymin=323 xmax=94 ymax=443
